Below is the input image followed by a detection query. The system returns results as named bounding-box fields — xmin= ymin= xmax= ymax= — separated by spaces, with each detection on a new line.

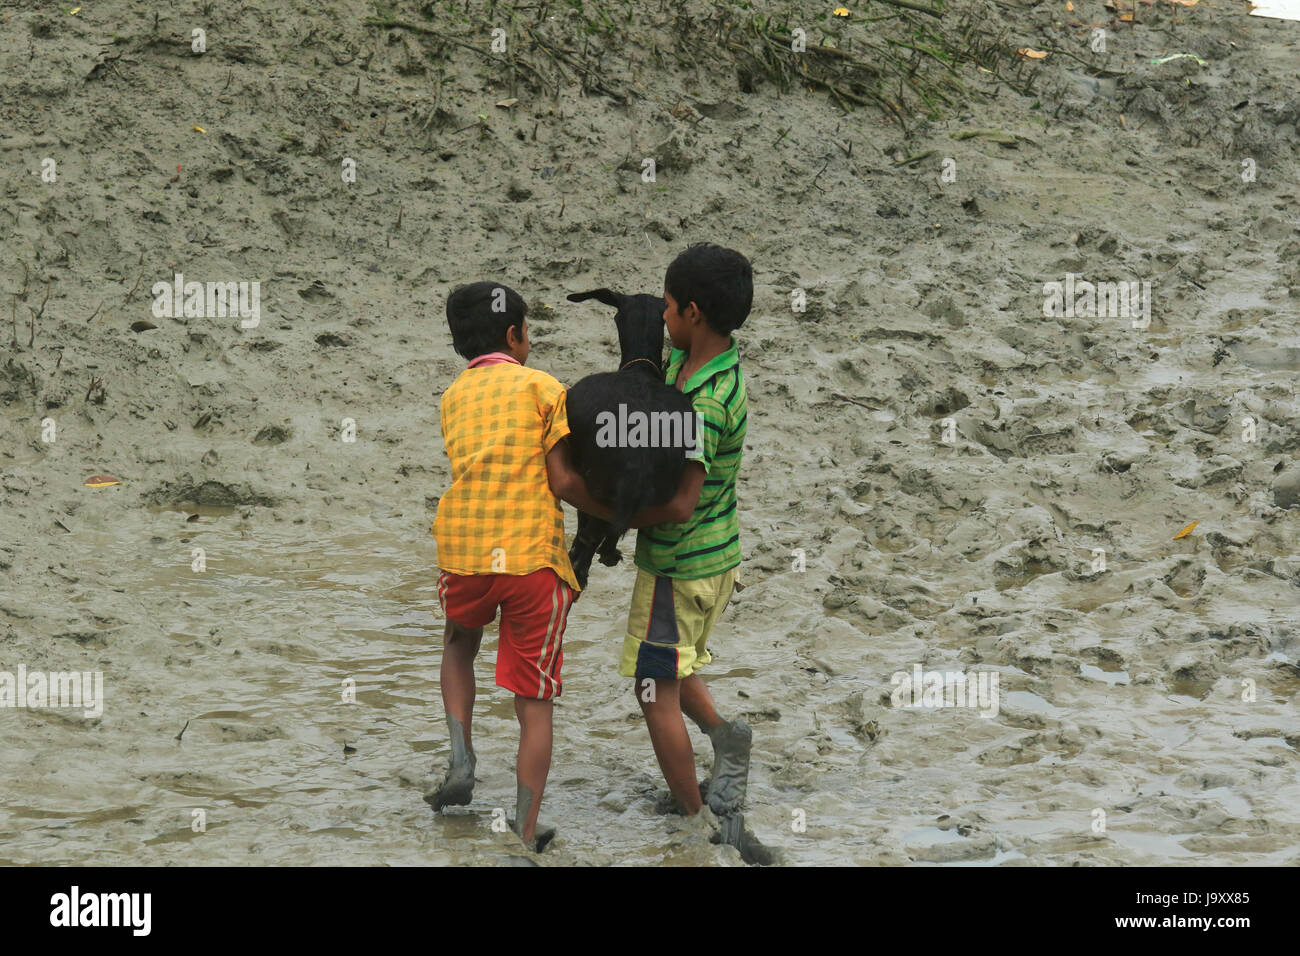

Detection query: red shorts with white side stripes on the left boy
xmin=438 ymin=567 xmax=576 ymax=700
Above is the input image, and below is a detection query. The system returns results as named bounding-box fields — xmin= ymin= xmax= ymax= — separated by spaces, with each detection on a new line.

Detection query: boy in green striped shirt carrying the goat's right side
xmin=619 ymin=245 xmax=754 ymax=845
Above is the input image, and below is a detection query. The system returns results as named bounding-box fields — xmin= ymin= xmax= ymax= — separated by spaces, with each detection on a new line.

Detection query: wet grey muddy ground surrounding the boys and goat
xmin=0 ymin=0 xmax=1300 ymax=865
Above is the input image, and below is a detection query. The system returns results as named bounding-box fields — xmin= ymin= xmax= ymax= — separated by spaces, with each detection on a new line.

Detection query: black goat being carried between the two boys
xmin=568 ymin=289 xmax=699 ymax=588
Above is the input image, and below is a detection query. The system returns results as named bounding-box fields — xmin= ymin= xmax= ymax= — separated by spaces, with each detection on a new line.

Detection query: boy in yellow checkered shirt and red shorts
xmin=425 ymin=282 xmax=608 ymax=852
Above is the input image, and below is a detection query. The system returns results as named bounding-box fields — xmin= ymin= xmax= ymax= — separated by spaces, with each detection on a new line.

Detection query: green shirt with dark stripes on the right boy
xmin=637 ymin=337 xmax=746 ymax=578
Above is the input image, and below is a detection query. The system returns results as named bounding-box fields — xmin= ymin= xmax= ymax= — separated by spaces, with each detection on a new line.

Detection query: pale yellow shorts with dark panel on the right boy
xmin=619 ymin=567 xmax=736 ymax=680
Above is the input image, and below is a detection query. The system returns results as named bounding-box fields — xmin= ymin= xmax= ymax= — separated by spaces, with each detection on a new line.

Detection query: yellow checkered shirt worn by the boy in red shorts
xmin=433 ymin=363 xmax=579 ymax=591
